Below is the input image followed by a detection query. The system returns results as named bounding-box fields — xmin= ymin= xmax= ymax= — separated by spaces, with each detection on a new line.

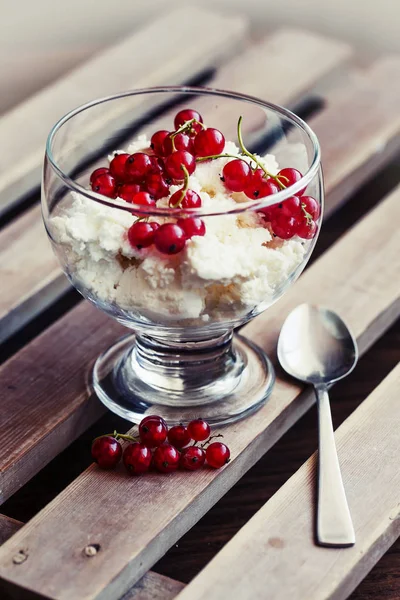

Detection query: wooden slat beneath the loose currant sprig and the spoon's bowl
xmin=0 ymin=188 xmax=400 ymax=600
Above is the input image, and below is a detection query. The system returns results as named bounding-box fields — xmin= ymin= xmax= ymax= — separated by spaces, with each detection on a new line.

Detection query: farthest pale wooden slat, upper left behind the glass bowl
xmin=0 ymin=6 xmax=247 ymax=214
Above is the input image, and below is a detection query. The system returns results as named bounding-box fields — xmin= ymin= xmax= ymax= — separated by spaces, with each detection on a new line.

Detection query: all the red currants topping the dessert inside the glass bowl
xmin=90 ymin=109 xmax=319 ymax=254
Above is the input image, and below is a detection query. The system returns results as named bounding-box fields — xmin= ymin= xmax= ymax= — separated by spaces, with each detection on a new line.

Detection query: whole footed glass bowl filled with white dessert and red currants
xmin=42 ymin=87 xmax=323 ymax=424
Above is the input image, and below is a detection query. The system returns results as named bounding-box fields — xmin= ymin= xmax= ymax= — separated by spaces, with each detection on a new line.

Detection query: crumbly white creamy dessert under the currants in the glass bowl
xmin=50 ymin=138 xmax=307 ymax=324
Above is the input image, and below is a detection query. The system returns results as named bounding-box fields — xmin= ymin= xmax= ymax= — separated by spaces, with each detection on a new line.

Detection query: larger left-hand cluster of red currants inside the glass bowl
xmin=90 ymin=109 xmax=225 ymax=254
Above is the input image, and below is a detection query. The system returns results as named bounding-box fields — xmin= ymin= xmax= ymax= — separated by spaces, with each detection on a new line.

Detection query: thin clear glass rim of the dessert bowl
xmin=45 ymin=85 xmax=321 ymax=217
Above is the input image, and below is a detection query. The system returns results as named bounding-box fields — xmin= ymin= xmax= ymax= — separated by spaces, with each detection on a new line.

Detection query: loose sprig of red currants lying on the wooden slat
xmin=92 ymin=415 xmax=230 ymax=475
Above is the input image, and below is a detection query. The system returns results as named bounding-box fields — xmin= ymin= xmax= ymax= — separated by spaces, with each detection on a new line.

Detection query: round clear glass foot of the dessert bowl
xmin=93 ymin=334 xmax=275 ymax=425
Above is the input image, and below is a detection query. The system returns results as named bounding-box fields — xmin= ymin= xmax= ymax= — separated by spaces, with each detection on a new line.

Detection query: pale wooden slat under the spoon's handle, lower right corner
xmin=179 ymin=365 xmax=400 ymax=600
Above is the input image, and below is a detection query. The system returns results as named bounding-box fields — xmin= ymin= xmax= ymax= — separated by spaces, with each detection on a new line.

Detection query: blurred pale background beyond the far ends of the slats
xmin=0 ymin=0 xmax=400 ymax=113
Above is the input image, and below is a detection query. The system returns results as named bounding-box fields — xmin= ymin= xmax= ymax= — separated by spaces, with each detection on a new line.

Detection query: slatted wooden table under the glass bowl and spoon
xmin=0 ymin=9 xmax=400 ymax=600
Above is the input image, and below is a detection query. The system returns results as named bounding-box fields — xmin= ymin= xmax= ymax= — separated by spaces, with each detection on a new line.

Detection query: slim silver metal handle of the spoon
xmin=315 ymin=387 xmax=355 ymax=548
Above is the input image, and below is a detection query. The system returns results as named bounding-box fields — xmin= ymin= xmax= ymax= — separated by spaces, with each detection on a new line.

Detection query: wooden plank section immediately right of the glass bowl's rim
xmin=310 ymin=56 xmax=400 ymax=216
